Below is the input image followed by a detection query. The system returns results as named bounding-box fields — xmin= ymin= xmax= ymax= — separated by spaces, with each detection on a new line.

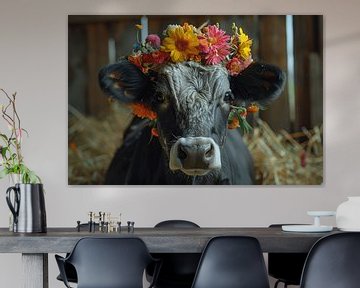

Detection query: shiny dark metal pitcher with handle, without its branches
xmin=6 ymin=184 xmax=46 ymax=233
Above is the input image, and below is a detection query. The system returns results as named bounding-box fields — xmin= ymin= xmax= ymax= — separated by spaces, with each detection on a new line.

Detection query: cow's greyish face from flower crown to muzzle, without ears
xmin=156 ymin=62 xmax=230 ymax=176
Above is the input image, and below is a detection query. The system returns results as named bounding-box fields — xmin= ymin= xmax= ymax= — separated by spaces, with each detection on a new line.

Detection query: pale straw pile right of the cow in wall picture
xmin=244 ymin=119 xmax=323 ymax=185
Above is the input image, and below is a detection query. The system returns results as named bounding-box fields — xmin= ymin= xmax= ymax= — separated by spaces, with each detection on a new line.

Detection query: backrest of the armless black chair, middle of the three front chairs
xmin=192 ymin=236 xmax=269 ymax=288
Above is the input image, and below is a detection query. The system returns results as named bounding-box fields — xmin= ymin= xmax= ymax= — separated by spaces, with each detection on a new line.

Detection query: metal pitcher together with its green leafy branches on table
xmin=0 ymin=89 xmax=47 ymax=233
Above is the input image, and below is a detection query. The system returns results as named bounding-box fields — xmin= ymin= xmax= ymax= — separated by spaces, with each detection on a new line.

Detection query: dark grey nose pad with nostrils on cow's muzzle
xmin=177 ymin=138 xmax=215 ymax=169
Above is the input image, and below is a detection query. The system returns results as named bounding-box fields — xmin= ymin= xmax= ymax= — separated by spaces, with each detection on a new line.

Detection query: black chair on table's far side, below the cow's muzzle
xmin=146 ymin=220 xmax=201 ymax=288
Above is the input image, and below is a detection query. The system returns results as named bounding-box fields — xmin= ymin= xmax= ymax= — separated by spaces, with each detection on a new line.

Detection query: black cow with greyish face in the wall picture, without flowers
xmin=99 ymin=60 xmax=285 ymax=185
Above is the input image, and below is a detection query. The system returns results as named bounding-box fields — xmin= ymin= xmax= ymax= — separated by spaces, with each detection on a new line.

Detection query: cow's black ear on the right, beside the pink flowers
xmin=230 ymin=63 xmax=286 ymax=106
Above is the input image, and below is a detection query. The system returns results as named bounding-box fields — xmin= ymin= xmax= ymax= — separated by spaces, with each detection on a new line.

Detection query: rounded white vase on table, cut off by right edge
xmin=336 ymin=196 xmax=360 ymax=231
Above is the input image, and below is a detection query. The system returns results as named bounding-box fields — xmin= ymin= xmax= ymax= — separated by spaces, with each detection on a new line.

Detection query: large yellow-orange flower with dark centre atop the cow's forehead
xmin=161 ymin=26 xmax=199 ymax=63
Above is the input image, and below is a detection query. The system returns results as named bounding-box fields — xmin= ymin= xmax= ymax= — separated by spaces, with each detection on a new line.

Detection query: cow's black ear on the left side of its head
xmin=99 ymin=59 xmax=151 ymax=102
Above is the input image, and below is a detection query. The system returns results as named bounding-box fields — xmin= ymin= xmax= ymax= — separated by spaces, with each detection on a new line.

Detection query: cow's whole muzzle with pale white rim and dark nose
xmin=169 ymin=137 xmax=221 ymax=176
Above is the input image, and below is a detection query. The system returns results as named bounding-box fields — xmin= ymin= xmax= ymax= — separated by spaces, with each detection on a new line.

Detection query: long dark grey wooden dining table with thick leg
xmin=0 ymin=227 xmax=338 ymax=288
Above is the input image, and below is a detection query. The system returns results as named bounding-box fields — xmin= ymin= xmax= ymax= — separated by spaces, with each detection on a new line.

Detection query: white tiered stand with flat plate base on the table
xmin=281 ymin=211 xmax=336 ymax=232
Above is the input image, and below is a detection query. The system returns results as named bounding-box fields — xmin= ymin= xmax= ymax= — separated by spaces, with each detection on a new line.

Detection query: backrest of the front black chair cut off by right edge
xmin=300 ymin=232 xmax=360 ymax=288
